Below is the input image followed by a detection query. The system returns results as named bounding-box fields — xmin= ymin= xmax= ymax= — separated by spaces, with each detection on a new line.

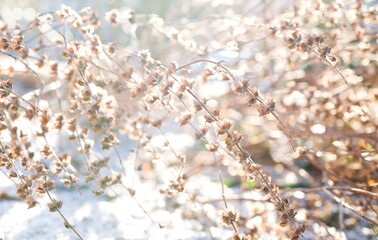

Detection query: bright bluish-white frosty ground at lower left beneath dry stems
xmin=0 ymin=172 xmax=216 ymax=240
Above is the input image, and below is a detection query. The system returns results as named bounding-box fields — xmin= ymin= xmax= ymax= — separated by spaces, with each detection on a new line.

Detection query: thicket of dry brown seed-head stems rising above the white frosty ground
xmin=0 ymin=1 xmax=378 ymax=239
